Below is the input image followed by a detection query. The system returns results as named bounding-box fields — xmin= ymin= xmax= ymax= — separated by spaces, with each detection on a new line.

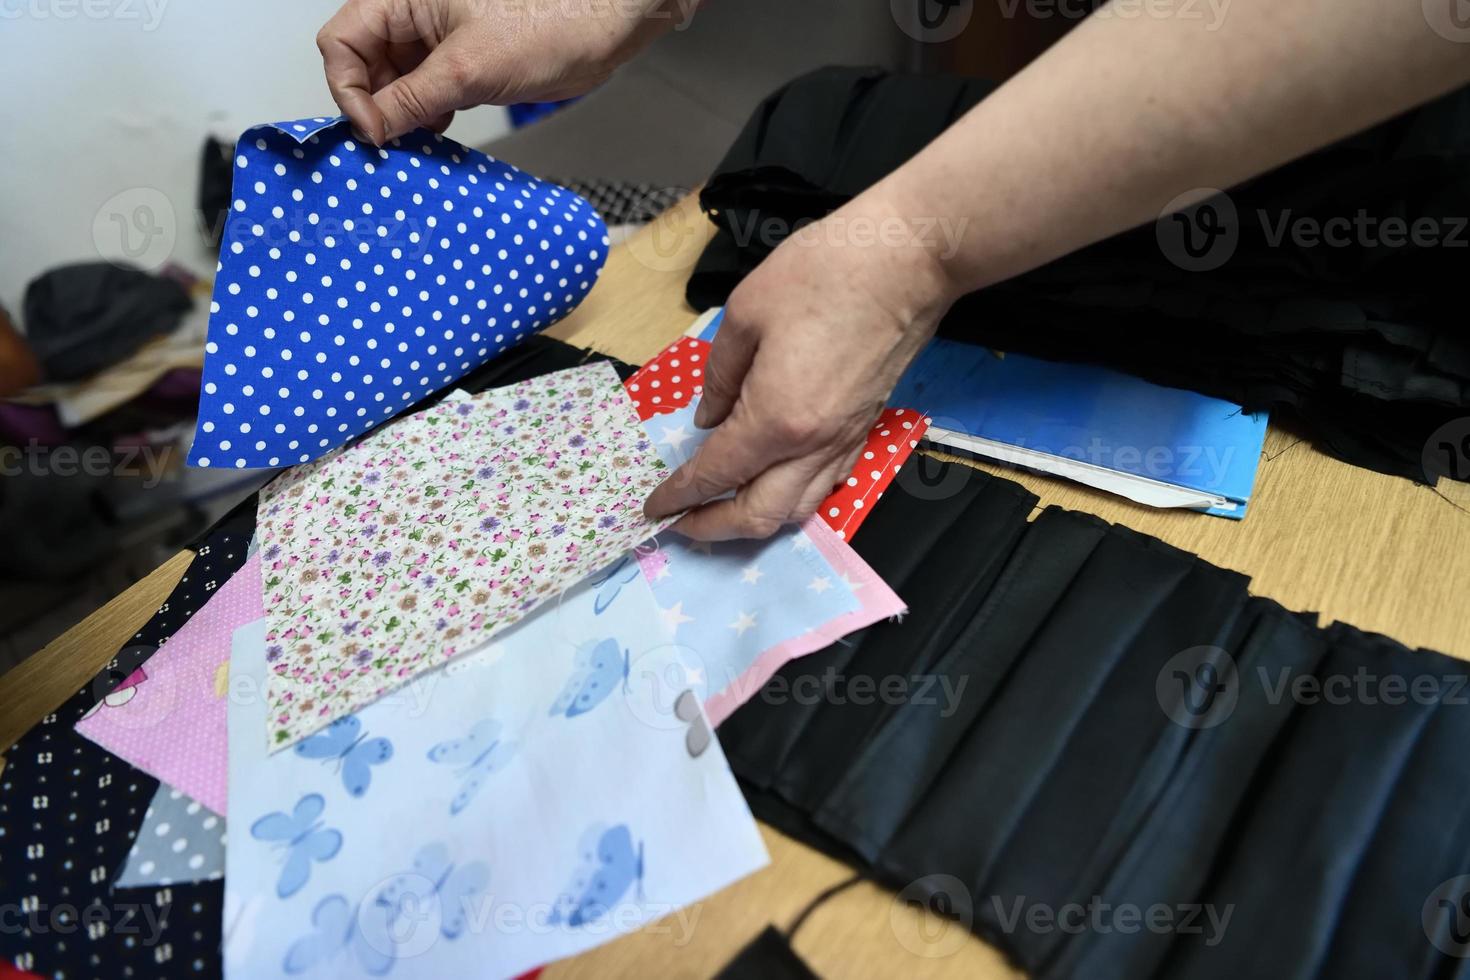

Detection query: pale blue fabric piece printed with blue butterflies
xmin=223 ymin=555 xmax=766 ymax=979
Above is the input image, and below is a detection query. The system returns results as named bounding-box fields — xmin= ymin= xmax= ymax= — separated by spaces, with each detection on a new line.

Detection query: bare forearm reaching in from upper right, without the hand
xmin=854 ymin=0 xmax=1470 ymax=294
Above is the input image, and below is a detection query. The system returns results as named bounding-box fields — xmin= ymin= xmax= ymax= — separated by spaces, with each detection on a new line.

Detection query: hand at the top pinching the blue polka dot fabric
xmin=316 ymin=0 xmax=692 ymax=145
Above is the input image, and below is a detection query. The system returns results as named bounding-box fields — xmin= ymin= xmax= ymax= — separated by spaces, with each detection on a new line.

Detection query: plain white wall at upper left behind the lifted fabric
xmin=0 ymin=0 xmax=509 ymax=320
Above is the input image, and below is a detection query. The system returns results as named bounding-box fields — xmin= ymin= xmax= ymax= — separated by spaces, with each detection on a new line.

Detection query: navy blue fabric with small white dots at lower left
xmin=0 ymin=507 xmax=254 ymax=980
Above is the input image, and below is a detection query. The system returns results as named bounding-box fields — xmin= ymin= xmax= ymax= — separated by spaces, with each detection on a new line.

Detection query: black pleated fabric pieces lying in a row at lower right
xmin=720 ymin=458 xmax=1470 ymax=979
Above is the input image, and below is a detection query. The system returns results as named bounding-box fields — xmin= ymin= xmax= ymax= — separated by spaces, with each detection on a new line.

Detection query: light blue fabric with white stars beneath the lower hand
xmin=644 ymin=400 xmax=861 ymax=698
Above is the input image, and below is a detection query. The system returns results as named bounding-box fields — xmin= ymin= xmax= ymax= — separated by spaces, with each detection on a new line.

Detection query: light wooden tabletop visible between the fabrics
xmin=0 ymin=198 xmax=1470 ymax=980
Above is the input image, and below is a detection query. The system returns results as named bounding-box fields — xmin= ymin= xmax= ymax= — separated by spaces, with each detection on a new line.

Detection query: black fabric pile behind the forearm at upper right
xmin=686 ymin=68 xmax=1470 ymax=480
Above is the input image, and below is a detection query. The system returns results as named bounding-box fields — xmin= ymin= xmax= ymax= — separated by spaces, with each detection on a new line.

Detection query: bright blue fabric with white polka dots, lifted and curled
xmin=190 ymin=118 xmax=607 ymax=467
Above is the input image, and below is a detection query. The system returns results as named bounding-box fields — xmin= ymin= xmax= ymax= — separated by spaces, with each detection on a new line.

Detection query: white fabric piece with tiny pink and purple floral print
xmin=259 ymin=363 xmax=672 ymax=749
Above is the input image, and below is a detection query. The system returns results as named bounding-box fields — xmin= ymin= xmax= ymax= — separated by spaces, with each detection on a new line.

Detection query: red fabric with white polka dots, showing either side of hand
xmin=623 ymin=336 xmax=929 ymax=541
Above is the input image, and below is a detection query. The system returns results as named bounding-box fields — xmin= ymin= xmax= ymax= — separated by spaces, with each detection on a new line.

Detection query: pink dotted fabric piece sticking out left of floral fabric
xmin=76 ymin=554 xmax=265 ymax=811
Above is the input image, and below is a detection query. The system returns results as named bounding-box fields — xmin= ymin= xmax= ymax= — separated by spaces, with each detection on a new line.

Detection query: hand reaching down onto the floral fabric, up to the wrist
xmin=644 ymin=185 xmax=956 ymax=541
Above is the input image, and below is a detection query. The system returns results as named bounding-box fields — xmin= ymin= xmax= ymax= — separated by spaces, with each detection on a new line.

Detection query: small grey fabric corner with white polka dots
xmin=113 ymin=781 xmax=228 ymax=887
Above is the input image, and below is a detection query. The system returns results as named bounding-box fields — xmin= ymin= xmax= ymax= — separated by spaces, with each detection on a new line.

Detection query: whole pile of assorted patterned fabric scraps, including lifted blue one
xmin=0 ymin=110 xmax=914 ymax=977
